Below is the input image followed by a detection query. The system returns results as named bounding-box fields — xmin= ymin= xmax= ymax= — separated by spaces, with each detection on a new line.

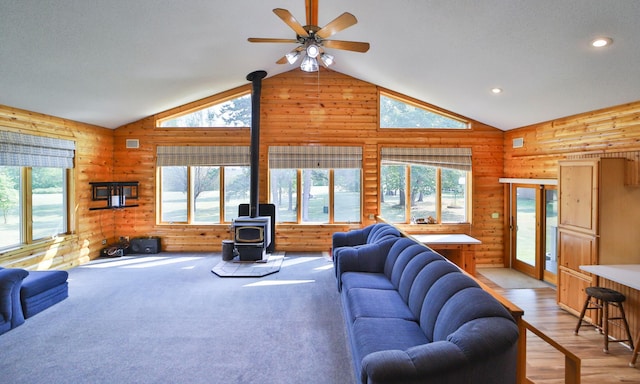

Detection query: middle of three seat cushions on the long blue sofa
xmin=346 ymin=288 xmax=415 ymax=321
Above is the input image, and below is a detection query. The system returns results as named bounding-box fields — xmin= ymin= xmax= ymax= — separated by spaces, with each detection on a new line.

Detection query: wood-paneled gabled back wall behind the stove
xmin=114 ymin=69 xmax=504 ymax=265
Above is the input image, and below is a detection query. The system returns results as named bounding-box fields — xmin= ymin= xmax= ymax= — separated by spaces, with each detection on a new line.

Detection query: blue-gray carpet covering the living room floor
xmin=0 ymin=253 xmax=354 ymax=384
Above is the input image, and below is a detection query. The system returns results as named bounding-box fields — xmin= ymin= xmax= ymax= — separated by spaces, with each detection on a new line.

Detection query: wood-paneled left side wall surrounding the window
xmin=0 ymin=105 xmax=116 ymax=270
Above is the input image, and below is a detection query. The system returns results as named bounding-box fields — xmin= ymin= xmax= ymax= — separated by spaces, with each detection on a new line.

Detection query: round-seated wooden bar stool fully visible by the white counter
xmin=574 ymin=287 xmax=635 ymax=352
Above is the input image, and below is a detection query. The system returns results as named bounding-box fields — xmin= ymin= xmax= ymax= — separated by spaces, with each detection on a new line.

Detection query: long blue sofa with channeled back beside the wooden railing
xmin=335 ymin=237 xmax=518 ymax=384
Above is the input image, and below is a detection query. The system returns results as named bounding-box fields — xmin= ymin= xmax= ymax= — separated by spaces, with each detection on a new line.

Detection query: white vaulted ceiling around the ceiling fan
xmin=0 ymin=0 xmax=640 ymax=130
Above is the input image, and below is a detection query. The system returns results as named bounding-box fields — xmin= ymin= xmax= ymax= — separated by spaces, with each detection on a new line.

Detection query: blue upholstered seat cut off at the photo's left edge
xmin=0 ymin=267 xmax=69 ymax=334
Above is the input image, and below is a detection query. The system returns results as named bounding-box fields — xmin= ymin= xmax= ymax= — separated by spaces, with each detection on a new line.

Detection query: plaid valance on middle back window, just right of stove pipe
xmin=269 ymin=146 xmax=362 ymax=169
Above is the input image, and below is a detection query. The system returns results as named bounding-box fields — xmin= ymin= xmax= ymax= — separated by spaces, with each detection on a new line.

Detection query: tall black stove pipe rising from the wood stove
xmin=247 ymin=71 xmax=267 ymax=217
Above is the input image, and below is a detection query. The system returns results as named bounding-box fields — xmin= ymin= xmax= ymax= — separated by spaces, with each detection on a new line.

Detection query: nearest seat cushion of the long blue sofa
xmin=352 ymin=317 xmax=429 ymax=363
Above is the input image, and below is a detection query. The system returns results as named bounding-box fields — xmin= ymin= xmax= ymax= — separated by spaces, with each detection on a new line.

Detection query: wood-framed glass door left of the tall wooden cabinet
xmin=511 ymin=184 xmax=558 ymax=284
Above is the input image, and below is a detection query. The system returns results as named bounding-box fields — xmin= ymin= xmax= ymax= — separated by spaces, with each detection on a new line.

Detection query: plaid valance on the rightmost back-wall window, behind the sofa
xmin=382 ymin=147 xmax=471 ymax=171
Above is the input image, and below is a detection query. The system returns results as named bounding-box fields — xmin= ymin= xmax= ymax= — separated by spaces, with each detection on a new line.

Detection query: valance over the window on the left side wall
xmin=0 ymin=131 xmax=76 ymax=168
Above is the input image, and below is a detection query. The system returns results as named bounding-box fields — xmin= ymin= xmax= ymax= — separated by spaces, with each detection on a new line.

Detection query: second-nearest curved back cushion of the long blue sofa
xmin=420 ymin=271 xmax=479 ymax=342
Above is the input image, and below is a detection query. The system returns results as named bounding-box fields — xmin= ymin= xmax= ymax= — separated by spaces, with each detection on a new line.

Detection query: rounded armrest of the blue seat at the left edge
xmin=0 ymin=268 xmax=29 ymax=328
